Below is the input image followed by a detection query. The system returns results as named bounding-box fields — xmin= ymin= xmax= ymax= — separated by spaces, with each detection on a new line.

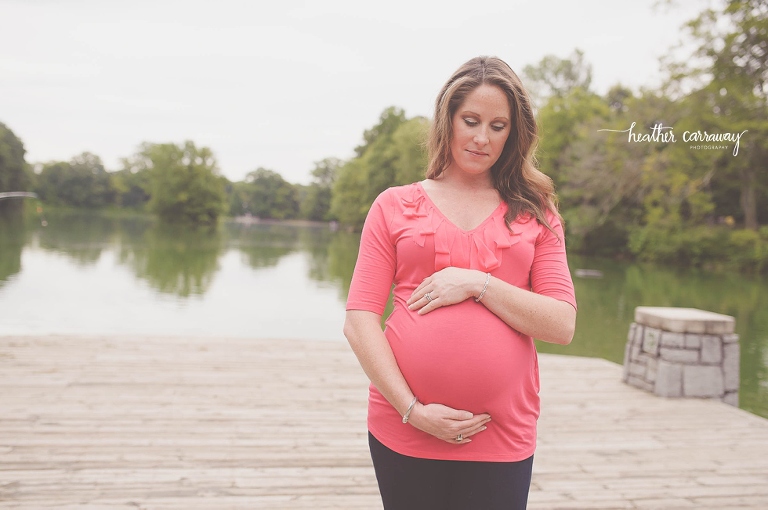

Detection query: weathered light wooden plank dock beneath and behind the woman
xmin=0 ymin=336 xmax=768 ymax=510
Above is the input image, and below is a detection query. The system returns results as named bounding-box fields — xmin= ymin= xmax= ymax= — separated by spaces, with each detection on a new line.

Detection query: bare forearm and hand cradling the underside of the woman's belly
xmin=344 ymin=310 xmax=491 ymax=444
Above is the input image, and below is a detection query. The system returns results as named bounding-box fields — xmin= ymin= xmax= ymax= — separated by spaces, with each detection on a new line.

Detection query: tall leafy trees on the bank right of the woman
xmin=512 ymin=0 xmax=768 ymax=271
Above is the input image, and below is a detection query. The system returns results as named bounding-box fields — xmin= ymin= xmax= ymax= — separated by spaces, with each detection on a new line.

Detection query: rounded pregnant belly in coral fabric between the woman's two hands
xmin=386 ymin=300 xmax=538 ymax=413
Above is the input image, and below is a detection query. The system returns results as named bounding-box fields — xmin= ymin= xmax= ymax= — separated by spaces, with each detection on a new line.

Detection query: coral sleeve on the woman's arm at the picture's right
xmin=531 ymin=211 xmax=576 ymax=308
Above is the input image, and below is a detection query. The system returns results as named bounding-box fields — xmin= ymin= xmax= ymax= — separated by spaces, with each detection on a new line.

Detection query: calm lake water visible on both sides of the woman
xmin=0 ymin=209 xmax=768 ymax=417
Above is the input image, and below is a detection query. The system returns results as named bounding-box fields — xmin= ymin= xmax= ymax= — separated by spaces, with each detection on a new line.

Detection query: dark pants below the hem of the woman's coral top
xmin=368 ymin=432 xmax=533 ymax=510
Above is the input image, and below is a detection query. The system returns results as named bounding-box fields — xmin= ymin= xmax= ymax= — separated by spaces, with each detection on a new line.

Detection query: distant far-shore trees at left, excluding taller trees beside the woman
xmin=0 ymin=131 xmax=340 ymax=225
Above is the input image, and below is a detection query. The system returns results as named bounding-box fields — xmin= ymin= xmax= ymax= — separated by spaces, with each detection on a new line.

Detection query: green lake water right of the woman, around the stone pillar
xmin=538 ymin=257 xmax=768 ymax=416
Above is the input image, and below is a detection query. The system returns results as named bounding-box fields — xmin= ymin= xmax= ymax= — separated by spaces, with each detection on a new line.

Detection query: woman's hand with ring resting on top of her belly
xmin=406 ymin=267 xmax=485 ymax=315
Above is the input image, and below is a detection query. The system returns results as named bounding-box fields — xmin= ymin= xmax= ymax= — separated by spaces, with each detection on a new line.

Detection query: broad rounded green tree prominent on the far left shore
xmin=131 ymin=141 xmax=225 ymax=225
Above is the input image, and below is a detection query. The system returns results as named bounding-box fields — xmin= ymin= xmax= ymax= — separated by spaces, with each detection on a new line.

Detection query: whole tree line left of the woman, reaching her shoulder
xmin=0 ymin=103 xmax=429 ymax=228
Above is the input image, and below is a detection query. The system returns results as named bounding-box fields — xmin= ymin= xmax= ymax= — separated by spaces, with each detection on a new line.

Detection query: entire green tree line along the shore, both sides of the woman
xmin=0 ymin=0 xmax=768 ymax=271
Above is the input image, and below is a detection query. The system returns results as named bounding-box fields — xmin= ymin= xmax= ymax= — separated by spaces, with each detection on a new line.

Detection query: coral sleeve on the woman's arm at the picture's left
xmin=347 ymin=187 xmax=397 ymax=315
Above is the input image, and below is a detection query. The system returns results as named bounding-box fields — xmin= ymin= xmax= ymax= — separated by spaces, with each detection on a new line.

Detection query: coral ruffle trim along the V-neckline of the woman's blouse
xmin=401 ymin=184 xmax=520 ymax=272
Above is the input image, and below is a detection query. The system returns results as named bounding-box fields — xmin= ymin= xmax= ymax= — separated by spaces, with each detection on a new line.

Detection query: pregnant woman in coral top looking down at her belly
xmin=344 ymin=57 xmax=576 ymax=510
